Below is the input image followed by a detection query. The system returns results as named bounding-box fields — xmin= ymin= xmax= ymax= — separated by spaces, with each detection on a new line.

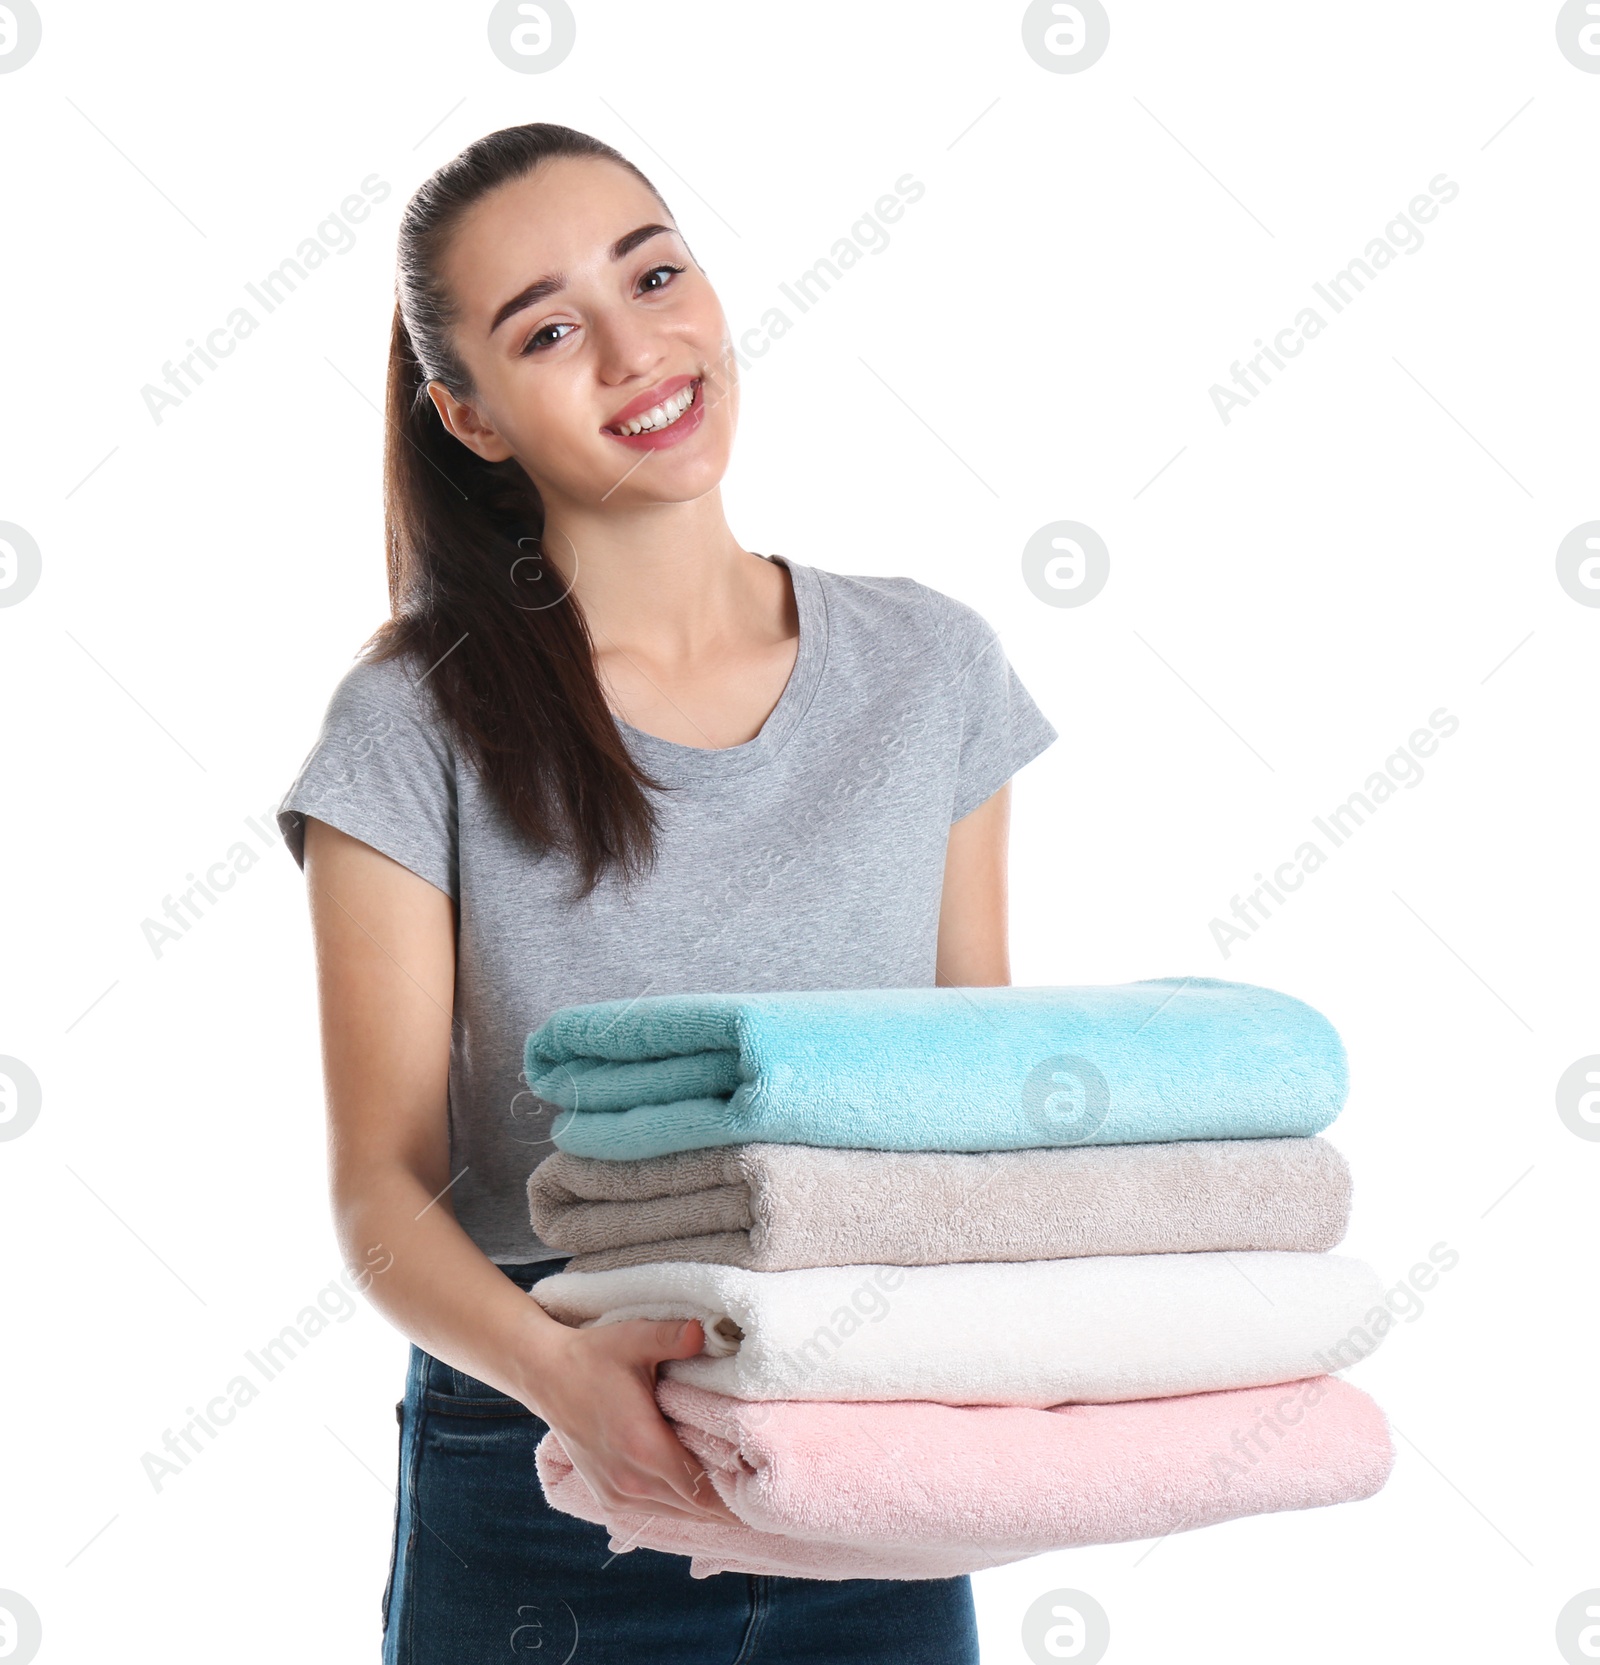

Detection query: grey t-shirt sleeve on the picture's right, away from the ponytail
xmin=929 ymin=591 xmax=1057 ymax=823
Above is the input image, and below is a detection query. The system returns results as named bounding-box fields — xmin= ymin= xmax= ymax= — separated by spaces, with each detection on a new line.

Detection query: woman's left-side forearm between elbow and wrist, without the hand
xmin=333 ymin=1164 xmax=573 ymax=1412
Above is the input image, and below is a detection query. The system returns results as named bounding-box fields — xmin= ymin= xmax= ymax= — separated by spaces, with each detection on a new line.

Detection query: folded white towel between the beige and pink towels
xmin=531 ymin=1249 xmax=1389 ymax=1407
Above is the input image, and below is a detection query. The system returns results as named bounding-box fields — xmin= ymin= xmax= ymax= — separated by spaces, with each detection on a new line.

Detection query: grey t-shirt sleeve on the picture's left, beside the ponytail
xmin=276 ymin=658 xmax=460 ymax=899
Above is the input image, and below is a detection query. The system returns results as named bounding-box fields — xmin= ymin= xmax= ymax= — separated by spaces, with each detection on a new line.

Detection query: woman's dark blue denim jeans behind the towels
xmin=383 ymin=1260 xmax=977 ymax=1665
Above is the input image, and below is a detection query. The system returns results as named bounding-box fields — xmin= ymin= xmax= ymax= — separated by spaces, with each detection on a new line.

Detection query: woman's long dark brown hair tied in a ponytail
xmin=363 ymin=122 xmax=666 ymax=896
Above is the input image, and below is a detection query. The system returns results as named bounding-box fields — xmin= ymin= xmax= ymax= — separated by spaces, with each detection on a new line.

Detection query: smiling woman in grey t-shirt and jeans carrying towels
xmin=278 ymin=123 xmax=1056 ymax=1665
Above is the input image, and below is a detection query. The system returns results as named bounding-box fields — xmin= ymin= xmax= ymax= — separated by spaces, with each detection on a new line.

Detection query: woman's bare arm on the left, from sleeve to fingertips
xmin=305 ymin=819 xmax=728 ymax=1518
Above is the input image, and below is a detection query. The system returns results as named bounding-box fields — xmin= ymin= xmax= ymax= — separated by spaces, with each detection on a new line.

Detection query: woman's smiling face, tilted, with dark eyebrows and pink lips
xmin=430 ymin=158 xmax=738 ymax=509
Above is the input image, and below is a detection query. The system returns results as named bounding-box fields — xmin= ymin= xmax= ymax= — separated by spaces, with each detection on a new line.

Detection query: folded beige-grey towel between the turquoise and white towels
xmin=528 ymin=1139 xmax=1350 ymax=1272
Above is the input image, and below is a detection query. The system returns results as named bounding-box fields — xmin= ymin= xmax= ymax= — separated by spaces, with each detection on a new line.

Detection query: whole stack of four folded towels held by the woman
xmin=526 ymin=977 xmax=1392 ymax=1578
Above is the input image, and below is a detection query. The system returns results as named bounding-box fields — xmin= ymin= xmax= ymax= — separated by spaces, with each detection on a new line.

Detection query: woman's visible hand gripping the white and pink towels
xmin=526 ymin=1319 xmax=738 ymax=1523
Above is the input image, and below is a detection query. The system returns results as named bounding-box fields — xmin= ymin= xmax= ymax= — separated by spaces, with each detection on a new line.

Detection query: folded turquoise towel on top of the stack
xmin=524 ymin=977 xmax=1347 ymax=1161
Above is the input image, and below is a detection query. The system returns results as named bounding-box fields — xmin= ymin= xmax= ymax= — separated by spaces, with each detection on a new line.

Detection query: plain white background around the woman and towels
xmin=0 ymin=0 xmax=1600 ymax=1665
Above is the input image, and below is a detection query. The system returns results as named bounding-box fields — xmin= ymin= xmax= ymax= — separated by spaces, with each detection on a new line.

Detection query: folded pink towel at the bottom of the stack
xmin=536 ymin=1375 xmax=1394 ymax=1578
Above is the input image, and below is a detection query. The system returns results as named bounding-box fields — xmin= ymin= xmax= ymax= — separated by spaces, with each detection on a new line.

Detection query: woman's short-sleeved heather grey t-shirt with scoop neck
xmin=278 ymin=556 xmax=1056 ymax=1264
